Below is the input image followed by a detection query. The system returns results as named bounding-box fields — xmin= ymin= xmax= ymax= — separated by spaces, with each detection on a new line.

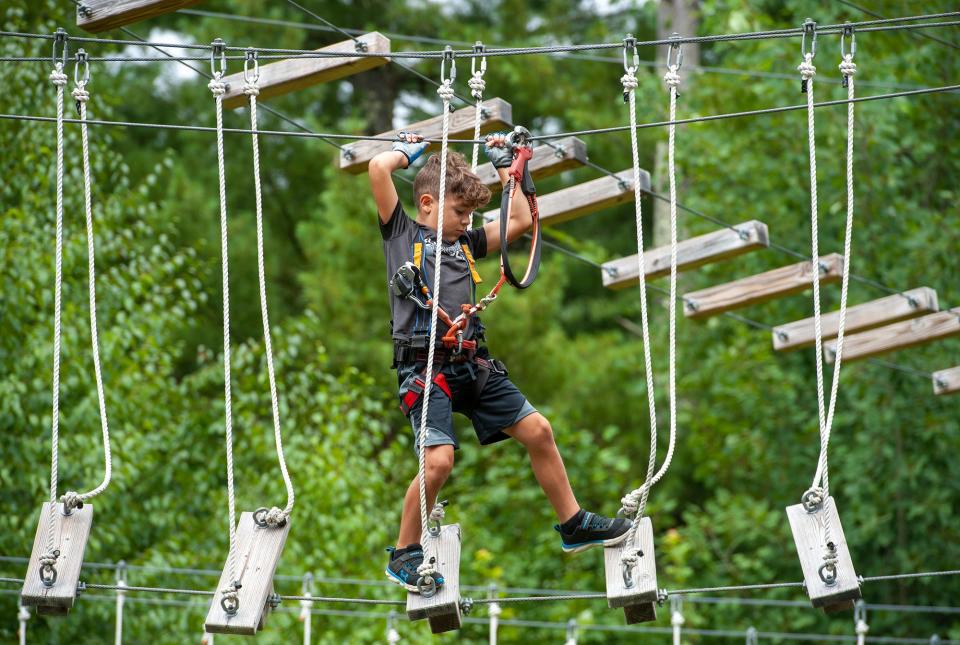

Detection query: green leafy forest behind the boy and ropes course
xmin=0 ymin=0 xmax=960 ymax=643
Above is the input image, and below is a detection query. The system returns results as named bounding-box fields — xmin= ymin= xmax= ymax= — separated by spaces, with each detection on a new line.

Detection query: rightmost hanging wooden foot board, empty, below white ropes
xmin=787 ymin=496 xmax=860 ymax=613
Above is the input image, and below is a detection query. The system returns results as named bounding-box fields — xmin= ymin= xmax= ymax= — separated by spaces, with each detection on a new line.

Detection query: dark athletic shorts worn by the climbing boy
xmin=397 ymin=350 xmax=536 ymax=454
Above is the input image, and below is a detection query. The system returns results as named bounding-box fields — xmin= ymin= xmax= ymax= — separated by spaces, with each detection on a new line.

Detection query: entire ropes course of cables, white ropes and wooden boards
xmin=0 ymin=0 xmax=960 ymax=643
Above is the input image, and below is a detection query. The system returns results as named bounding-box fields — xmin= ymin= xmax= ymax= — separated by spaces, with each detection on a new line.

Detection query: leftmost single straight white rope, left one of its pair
xmin=40 ymin=62 xmax=67 ymax=568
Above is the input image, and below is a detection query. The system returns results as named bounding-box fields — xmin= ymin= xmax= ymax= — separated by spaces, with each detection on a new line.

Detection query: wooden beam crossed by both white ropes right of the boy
xmin=602 ymin=220 xmax=770 ymax=289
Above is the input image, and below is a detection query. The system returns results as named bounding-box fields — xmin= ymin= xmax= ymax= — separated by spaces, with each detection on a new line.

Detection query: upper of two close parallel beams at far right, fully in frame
xmin=773 ymin=287 xmax=940 ymax=351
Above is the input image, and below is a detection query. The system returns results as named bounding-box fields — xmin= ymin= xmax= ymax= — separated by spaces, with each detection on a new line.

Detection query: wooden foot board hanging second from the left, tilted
xmin=204 ymin=512 xmax=290 ymax=636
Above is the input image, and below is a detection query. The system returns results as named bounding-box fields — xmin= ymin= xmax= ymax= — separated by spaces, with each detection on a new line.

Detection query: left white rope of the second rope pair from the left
xmin=207 ymin=71 xmax=239 ymax=588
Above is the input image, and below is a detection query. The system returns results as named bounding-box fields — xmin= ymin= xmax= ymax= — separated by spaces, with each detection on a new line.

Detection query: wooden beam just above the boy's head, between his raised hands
xmin=340 ymin=98 xmax=513 ymax=175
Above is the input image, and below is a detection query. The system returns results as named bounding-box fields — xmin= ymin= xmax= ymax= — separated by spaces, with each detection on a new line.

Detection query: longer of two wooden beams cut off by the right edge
xmin=823 ymin=307 xmax=960 ymax=363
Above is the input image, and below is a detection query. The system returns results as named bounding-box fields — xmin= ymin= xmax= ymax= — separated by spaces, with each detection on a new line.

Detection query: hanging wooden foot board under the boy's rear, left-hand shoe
xmin=407 ymin=524 xmax=462 ymax=634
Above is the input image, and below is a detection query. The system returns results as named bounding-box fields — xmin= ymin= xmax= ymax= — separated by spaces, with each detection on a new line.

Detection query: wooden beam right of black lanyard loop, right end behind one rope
xmin=483 ymin=170 xmax=650 ymax=225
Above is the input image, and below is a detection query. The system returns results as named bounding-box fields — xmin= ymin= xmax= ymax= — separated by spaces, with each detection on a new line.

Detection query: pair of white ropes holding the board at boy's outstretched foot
xmin=620 ymin=59 xmax=680 ymax=564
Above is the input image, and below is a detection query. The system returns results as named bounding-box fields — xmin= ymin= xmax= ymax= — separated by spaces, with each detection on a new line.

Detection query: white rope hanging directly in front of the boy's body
xmin=417 ymin=79 xmax=454 ymax=577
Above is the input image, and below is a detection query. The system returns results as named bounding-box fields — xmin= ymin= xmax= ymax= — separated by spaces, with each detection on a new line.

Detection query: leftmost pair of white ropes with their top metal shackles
xmin=38 ymin=34 xmax=113 ymax=587
